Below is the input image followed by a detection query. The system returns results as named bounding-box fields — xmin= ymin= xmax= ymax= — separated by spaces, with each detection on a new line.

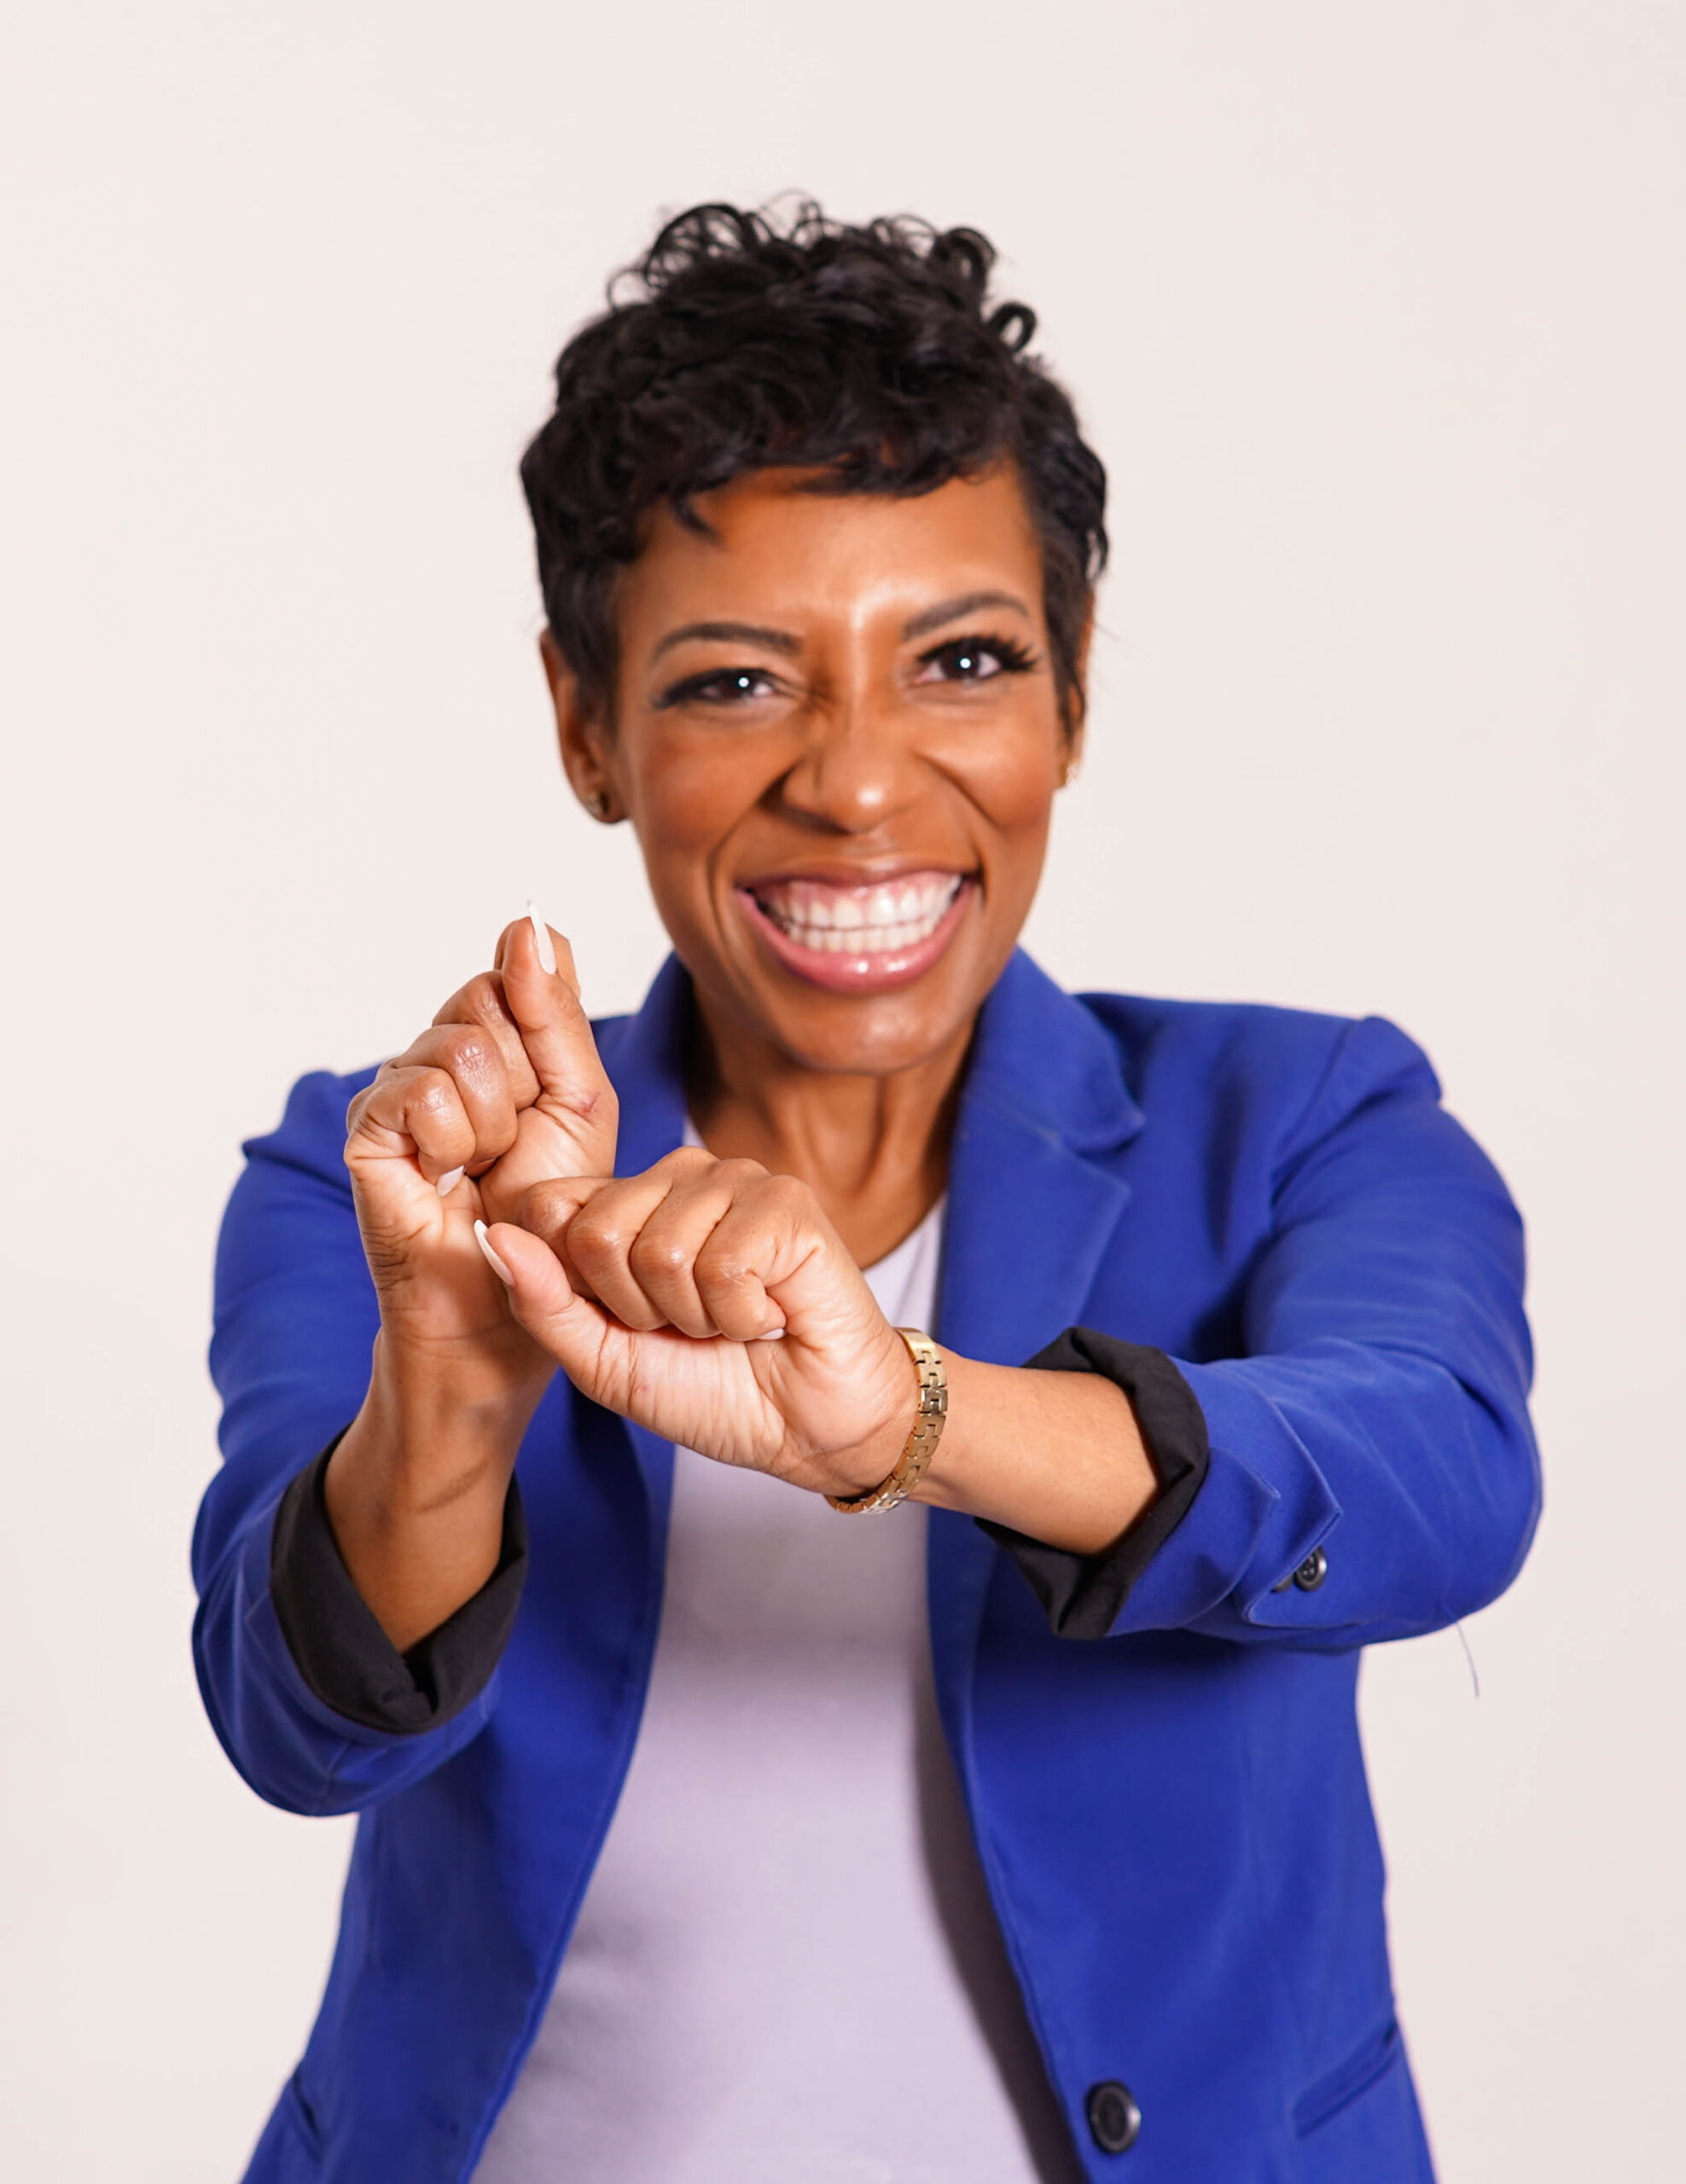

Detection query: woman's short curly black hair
xmin=522 ymin=201 xmax=1108 ymax=727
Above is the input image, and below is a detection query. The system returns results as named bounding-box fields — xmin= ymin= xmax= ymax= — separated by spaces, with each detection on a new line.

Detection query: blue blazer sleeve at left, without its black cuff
xmin=192 ymin=1072 xmax=498 ymax=1813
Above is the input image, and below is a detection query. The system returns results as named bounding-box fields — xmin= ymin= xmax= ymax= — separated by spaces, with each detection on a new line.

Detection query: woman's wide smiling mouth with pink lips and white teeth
xmin=738 ymin=871 xmax=976 ymax=991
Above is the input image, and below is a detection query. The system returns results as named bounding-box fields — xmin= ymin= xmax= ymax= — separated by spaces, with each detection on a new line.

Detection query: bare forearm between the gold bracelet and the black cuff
xmin=913 ymin=1350 xmax=1158 ymax=1555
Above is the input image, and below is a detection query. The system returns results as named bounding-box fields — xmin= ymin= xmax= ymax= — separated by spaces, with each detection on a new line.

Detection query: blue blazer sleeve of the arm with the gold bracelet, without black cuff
xmin=1091 ymin=1018 xmax=1540 ymax=1649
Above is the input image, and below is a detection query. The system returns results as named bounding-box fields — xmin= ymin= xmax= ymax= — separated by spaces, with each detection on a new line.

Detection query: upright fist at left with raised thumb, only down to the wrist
xmin=345 ymin=917 xmax=616 ymax=1380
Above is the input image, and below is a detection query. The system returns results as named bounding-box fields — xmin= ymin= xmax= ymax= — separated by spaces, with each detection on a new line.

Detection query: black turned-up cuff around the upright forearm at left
xmin=269 ymin=1432 xmax=526 ymax=1736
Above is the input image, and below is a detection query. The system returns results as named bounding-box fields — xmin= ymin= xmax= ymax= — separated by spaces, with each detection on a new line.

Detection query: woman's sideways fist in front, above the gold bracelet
xmin=487 ymin=1149 xmax=917 ymax=1494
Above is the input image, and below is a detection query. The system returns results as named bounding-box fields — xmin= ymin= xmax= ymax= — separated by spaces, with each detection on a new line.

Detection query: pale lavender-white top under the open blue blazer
xmin=476 ymin=1208 xmax=1073 ymax=2184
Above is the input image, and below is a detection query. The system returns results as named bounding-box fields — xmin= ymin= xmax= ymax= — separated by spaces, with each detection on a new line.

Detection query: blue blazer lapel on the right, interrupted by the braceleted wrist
xmin=928 ymin=952 xmax=1142 ymax=1778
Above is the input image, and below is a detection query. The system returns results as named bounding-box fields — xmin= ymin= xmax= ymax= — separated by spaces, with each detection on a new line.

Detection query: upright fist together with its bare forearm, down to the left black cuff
xmin=323 ymin=917 xmax=618 ymax=1651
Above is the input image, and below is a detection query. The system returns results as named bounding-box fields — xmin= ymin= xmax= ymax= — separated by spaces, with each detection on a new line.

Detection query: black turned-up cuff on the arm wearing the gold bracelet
xmin=979 ymin=1327 xmax=1210 ymax=1638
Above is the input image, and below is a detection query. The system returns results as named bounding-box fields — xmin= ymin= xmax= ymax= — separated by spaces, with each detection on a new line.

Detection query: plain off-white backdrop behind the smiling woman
xmin=0 ymin=0 xmax=1686 ymax=2184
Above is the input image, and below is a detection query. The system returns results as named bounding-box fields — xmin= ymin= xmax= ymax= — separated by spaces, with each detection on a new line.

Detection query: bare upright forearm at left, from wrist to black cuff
xmin=323 ymin=1337 xmax=548 ymax=1653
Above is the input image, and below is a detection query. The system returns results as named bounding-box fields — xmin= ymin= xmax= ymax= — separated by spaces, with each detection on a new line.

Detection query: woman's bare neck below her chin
xmin=688 ymin=991 xmax=972 ymax=1267
